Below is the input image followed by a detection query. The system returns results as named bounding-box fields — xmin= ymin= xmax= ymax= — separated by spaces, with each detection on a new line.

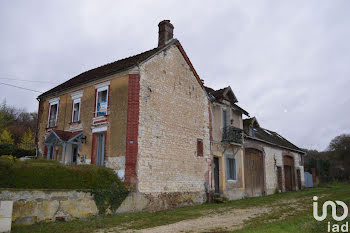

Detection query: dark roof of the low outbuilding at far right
xmin=243 ymin=117 xmax=303 ymax=151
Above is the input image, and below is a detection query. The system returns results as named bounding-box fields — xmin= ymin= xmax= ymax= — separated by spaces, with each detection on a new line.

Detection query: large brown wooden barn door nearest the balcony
xmin=244 ymin=149 xmax=264 ymax=196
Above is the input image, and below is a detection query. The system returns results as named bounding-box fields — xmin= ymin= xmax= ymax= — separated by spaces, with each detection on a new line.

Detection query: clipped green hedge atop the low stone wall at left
xmin=0 ymin=156 xmax=124 ymax=189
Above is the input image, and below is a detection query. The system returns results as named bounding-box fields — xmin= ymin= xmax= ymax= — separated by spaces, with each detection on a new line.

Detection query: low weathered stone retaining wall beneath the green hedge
xmin=0 ymin=189 xmax=98 ymax=224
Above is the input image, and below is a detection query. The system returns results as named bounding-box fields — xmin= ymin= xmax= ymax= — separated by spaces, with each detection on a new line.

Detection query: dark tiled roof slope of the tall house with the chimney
xmin=38 ymin=39 xmax=177 ymax=98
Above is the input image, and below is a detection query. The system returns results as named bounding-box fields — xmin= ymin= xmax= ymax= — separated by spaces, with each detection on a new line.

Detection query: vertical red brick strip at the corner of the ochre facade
xmin=125 ymin=74 xmax=140 ymax=184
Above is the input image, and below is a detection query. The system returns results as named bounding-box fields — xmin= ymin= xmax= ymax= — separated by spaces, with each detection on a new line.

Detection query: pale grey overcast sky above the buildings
xmin=0 ymin=0 xmax=350 ymax=150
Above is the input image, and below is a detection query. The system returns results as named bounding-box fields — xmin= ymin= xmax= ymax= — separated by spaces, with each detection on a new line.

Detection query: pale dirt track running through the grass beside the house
xmin=96 ymin=197 xmax=318 ymax=233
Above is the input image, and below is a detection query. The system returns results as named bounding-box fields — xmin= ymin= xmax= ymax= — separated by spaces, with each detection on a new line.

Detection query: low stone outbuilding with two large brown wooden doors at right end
xmin=243 ymin=117 xmax=305 ymax=196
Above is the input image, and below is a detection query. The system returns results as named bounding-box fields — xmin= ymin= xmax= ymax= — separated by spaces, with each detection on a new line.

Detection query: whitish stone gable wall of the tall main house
xmin=137 ymin=45 xmax=210 ymax=195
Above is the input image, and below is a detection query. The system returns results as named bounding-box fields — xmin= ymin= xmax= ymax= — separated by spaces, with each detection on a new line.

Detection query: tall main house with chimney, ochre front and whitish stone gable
xmin=37 ymin=20 xmax=210 ymax=208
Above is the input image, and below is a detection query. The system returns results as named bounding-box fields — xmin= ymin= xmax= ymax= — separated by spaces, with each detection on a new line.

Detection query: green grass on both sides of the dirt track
xmin=12 ymin=183 xmax=350 ymax=233
